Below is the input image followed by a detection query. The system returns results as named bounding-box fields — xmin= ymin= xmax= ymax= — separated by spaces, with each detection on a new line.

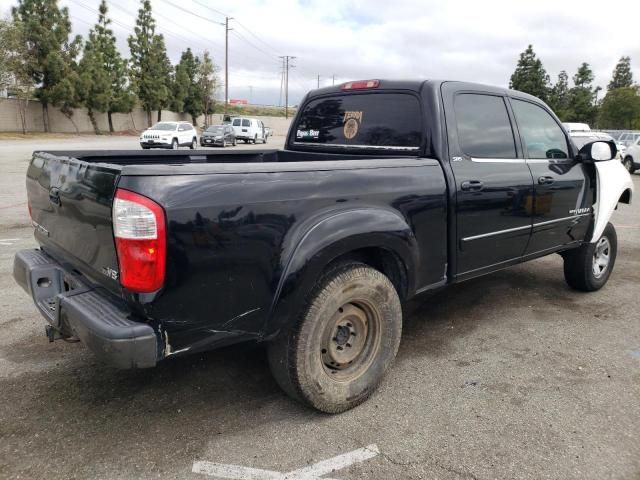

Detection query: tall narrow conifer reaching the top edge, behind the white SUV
xmin=128 ymin=0 xmax=170 ymax=126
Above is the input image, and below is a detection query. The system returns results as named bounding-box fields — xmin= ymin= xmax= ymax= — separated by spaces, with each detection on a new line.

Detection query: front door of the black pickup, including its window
xmin=510 ymin=98 xmax=593 ymax=254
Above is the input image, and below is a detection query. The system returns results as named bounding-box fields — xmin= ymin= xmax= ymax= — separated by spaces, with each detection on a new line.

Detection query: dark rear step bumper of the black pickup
xmin=13 ymin=250 xmax=161 ymax=368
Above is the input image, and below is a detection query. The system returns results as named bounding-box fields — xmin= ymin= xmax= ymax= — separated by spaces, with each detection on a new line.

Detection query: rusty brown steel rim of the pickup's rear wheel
xmin=320 ymin=300 xmax=382 ymax=382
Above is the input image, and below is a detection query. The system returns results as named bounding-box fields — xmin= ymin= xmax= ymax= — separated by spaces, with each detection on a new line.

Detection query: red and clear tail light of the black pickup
xmin=113 ymin=189 xmax=167 ymax=293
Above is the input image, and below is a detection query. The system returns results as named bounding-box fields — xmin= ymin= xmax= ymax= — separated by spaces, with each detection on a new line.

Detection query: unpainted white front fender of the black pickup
xmin=589 ymin=159 xmax=633 ymax=243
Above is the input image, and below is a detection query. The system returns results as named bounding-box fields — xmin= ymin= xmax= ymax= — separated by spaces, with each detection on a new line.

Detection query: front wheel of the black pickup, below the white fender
xmin=564 ymin=223 xmax=618 ymax=292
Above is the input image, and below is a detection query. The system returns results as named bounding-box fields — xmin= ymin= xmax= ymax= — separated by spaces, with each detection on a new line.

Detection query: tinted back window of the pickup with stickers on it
xmin=293 ymin=93 xmax=422 ymax=148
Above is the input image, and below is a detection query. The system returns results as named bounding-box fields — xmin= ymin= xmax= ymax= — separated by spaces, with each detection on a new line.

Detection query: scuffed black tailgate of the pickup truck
xmin=27 ymin=152 xmax=120 ymax=293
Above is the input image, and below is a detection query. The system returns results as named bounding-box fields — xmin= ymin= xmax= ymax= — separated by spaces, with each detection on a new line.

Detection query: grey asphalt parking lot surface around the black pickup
xmin=0 ymin=136 xmax=640 ymax=480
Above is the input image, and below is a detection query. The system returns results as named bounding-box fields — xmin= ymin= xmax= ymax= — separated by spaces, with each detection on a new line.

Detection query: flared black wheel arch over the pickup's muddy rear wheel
xmin=264 ymin=208 xmax=418 ymax=337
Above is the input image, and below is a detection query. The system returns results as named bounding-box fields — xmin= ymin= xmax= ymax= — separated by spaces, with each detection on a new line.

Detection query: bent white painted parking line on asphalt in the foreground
xmin=191 ymin=444 xmax=380 ymax=480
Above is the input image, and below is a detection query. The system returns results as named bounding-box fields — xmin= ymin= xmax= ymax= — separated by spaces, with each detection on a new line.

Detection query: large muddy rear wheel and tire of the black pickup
xmin=268 ymin=262 xmax=402 ymax=413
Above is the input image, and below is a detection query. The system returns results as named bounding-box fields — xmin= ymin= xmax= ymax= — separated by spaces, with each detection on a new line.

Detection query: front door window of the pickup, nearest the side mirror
xmin=511 ymin=99 xmax=569 ymax=158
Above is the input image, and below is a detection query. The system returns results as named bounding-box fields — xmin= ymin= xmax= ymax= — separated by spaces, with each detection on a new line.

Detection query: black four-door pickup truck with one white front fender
xmin=14 ymin=80 xmax=633 ymax=412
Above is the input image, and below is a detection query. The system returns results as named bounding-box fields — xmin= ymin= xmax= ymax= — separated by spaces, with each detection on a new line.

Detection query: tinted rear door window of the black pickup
xmin=454 ymin=93 xmax=516 ymax=158
